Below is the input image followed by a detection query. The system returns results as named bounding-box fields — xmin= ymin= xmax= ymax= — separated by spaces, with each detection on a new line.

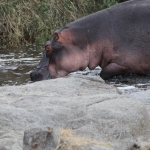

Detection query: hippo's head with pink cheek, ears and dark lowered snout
xmin=30 ymin=29 xmax=88 ymax=81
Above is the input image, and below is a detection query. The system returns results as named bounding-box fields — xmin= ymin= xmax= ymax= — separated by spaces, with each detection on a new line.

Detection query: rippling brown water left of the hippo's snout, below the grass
xmin=0 ymin=45 xmax=43 ymax=86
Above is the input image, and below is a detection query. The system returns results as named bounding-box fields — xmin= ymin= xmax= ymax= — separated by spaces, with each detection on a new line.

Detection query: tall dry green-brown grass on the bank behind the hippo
xmin=0 ymin=0 xmax=126 ymax=46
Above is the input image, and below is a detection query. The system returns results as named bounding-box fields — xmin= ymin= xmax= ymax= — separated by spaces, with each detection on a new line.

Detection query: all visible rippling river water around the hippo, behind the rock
xmin=0 ymin=45 xmax=150 ymax=93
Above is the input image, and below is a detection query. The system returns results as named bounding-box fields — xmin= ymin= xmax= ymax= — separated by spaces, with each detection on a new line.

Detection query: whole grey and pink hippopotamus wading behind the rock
xmin=30 ymin=0 xmax=150 ymax=81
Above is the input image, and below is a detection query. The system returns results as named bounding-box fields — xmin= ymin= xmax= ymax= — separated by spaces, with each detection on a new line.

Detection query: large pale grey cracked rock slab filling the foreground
xmin=0 ymin=75 xmax=150 ymax=150
